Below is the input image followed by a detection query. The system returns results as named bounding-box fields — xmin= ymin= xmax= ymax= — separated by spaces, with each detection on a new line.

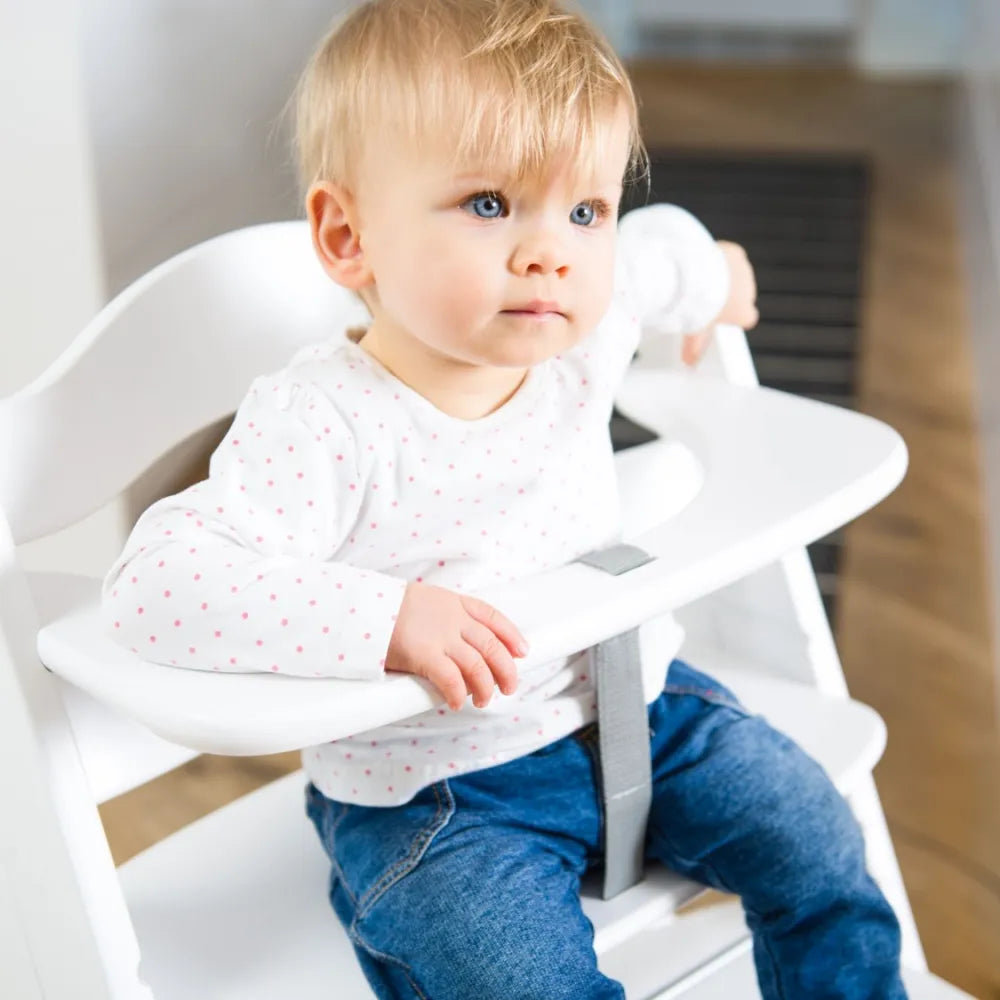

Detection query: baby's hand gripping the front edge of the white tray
xmin=385 ymin=583 xmax=528 ymax=711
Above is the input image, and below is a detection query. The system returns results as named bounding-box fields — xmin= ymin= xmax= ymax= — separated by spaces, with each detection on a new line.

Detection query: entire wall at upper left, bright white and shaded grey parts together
xmin=0 ymin=0 xmax=348 ymax=386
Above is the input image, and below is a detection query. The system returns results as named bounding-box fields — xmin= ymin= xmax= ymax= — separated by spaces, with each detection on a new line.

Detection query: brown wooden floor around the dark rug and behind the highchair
xmin=95 ymin=64 xmax=1000 ymax=1000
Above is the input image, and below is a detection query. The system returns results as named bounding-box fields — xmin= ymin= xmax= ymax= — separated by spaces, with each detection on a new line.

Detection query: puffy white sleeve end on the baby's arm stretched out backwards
xmin=616 ymin=204 xmax=729 ymax=334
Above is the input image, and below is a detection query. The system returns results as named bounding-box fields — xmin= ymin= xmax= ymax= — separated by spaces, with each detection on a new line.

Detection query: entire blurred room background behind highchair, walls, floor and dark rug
xmin=0 ymin=0 xmax=1000 ymax=998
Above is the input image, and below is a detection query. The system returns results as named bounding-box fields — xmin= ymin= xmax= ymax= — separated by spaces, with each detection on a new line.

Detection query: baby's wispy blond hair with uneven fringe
xmin=294 ymin=0 xmax=647 ymax=193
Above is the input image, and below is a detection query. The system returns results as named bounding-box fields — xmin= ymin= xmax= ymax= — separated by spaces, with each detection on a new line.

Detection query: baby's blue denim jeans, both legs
xmin=307 ymin=660 xmax=906 ymax=1000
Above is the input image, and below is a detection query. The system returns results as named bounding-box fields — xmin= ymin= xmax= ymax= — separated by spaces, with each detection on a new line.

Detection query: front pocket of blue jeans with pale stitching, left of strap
xmin=329 ymin=781 xmax=455 ymax=919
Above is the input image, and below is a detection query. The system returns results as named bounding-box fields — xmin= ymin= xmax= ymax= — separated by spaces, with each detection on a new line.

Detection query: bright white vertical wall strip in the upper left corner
xmin=0 ymin=0 xmax=103 ymax=395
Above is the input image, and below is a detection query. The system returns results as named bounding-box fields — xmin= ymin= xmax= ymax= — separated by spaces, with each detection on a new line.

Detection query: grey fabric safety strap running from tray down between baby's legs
xmin=580 ymin=545 xmax=653 ymax=899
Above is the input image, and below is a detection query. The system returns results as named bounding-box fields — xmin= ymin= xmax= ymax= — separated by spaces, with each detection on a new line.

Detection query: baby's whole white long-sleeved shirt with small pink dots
xmin=103 ymin=205 xmax=728 ymax=805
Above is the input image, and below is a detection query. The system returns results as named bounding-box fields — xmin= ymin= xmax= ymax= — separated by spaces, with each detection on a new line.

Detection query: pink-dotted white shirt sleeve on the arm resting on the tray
xmin=102 ymin=376 xmax=406 ymax=679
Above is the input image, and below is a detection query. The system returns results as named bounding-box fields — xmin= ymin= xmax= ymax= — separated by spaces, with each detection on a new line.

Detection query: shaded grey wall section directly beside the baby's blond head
xmin=83 ymin=0 xmax=348 ymax=291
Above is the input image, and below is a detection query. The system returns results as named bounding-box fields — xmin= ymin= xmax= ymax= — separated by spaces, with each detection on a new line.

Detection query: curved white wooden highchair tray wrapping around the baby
xmin=38 ymin=370 xmax=906 ymax=754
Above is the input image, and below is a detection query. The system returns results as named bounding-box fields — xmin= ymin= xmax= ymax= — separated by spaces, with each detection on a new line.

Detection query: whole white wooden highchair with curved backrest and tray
xmin=0 ymin=222 xmax=964 ymax=1000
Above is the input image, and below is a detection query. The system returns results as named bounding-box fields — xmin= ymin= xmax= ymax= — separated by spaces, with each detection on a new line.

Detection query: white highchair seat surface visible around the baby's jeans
xmin=111 ymin=664 xmax=885 ymax=1000
